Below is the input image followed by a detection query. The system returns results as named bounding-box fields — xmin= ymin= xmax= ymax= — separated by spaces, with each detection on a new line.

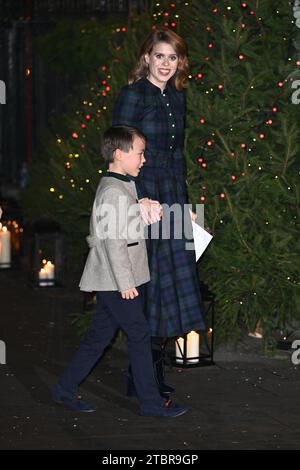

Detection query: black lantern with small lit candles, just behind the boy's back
xmin=31 ymin=223 xmax=64 ymax=287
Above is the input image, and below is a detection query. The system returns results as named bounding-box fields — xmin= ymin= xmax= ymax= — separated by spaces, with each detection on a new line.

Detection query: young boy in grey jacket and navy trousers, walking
xmin=53 ymin=126 xmax=187 ymax=417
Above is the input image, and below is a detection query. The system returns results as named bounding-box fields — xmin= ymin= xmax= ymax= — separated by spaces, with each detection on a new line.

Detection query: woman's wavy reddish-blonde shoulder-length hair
xmin=129 ymin=28 xmax=189 ymax=91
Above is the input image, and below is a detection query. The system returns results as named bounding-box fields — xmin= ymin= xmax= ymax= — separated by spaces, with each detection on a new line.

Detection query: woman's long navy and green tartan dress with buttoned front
xmin=113 ymin=78 xmax=205 ymax=338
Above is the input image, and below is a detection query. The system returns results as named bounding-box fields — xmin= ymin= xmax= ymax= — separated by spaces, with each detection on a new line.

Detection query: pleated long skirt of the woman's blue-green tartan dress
xmin=139 ymin=166 xmax=205 ymax=338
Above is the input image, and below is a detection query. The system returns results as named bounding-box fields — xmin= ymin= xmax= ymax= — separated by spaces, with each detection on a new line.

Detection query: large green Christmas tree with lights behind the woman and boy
xmin=25 ymin=0 xmax=300 ymax=346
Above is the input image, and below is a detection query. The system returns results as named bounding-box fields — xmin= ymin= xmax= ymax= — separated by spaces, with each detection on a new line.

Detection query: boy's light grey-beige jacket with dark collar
xmin=79 ymin=172 xmax=150 ymax=292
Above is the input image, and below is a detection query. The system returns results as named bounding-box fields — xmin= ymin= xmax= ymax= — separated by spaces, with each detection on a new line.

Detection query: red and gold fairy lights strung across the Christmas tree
xmin=44 ymin=1 xmax=300 ymax=298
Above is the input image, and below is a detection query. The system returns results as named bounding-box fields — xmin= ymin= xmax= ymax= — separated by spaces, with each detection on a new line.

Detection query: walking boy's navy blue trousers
xmin=59 ymin=286 xmax=162 ymax=405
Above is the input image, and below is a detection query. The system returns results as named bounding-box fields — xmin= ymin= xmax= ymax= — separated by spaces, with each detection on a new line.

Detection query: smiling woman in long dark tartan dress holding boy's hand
xmin=113 ymin=28 xmax=204 ymax=393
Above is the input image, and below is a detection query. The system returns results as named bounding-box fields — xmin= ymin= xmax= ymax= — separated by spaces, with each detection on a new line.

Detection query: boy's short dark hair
xmin=101 ymin=126 xmax=146 ymax=164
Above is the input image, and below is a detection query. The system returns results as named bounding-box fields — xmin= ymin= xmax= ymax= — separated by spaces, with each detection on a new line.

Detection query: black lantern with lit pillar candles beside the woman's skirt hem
xmin=172 ymin=283 xmax=215 ymax=367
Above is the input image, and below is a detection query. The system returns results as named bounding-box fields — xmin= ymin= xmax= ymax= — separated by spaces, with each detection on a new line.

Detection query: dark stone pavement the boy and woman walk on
xmin=0 ymin=270 xmax=300 ymax=452
